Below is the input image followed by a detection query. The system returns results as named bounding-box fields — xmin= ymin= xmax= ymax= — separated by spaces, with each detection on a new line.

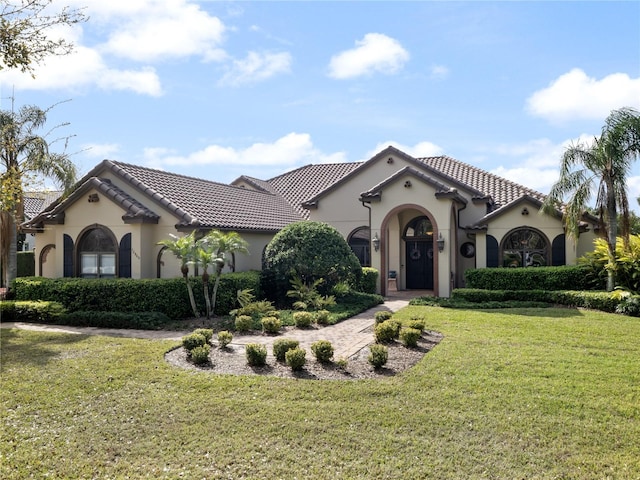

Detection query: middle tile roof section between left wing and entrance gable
xmin=267 ymin=162 xmax=363 ymax=219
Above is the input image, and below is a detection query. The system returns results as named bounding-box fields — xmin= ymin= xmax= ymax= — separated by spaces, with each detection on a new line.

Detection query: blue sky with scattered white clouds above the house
xmin=0 ymin=0 xmax=640 ymax=211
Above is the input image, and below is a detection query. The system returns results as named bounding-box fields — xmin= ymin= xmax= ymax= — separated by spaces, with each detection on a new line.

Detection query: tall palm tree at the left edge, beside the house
xmin=0 ymin=106 xmax=76 ymax=286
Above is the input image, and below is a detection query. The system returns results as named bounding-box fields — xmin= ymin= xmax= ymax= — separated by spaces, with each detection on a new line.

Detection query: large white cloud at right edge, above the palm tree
xmin=526 ymin=68 xmax=640 ymax=122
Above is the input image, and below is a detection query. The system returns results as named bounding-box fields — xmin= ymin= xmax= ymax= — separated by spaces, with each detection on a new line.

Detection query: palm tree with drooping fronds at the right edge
xmin=542 ymin=108 xmax=640 ymax=291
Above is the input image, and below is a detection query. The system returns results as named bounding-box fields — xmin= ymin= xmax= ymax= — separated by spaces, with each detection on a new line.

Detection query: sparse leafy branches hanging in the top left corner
xmin=0 ymin=0 xmax=87 ymax=75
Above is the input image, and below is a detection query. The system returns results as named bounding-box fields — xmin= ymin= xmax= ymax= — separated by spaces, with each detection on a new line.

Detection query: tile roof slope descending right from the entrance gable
xmin=417 ymin=156 xmax=545 ymax=210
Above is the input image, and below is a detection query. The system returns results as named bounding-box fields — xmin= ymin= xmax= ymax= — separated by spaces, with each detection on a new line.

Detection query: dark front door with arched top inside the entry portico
xmin=402 ymin=216 xmax=434 ymax=290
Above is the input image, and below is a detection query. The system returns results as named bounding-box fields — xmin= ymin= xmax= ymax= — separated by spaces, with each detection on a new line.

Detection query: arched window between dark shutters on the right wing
xmin=502 ymin=227 xmax=549 ymax=267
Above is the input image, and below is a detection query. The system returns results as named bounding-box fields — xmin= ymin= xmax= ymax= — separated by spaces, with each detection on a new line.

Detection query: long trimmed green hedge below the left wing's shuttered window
xmin=14 ymin=271 xmax=261 ymax=319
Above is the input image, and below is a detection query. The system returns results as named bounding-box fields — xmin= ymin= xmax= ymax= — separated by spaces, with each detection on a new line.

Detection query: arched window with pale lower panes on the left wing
xmin=78 ymin=226 xmax=117 ymax=278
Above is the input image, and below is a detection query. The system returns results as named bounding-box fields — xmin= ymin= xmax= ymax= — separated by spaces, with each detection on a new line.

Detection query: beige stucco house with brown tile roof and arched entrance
xmin=24 ymin=147 xmax=596 ymax=297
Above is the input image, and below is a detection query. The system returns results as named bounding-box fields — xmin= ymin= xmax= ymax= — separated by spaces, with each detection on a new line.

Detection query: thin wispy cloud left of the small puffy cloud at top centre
xmin=218 ymin=52 xmax=291 ymax=87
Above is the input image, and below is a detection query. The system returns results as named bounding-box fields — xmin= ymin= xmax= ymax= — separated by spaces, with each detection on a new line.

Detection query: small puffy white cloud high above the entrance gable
xmin=329 ymin=33 xmax=409 ymax=79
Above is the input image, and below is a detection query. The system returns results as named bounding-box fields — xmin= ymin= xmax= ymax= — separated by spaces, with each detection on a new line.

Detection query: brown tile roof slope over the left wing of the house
xmin=110 ymin=162 xmax=301 ymax=231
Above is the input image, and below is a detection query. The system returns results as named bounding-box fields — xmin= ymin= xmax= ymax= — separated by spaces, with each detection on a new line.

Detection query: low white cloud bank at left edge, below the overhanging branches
xmin=0 ymin=46 xmax=162 ymax=96
